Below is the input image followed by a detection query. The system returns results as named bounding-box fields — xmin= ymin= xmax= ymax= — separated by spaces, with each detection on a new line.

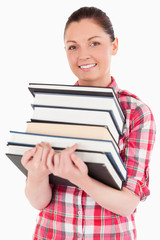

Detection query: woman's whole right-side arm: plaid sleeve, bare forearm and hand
xmin=49 ymin=101 xmax=155 ymax=216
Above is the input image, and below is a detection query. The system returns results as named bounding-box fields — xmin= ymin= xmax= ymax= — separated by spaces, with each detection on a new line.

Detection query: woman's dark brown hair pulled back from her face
xmin=64 ymin=7 xmax=115 ymax=41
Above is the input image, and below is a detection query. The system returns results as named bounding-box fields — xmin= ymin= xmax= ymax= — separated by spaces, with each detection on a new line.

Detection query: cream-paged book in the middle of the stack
xmin=26 ymin=122 xmax=119 ymax=151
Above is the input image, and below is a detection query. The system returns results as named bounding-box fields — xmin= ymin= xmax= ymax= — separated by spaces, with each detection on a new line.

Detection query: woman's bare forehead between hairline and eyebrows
xmin=65 ymin=19 xmax=108 ymax=41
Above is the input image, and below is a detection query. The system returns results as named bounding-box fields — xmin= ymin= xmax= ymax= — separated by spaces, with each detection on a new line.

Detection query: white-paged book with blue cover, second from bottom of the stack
xmin=8 ymin=131 xmax=127 ymax=181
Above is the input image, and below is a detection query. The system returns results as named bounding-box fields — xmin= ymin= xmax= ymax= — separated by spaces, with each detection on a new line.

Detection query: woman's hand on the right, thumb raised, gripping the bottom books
xmin=48 ymin=144 xmax=88 ymax=185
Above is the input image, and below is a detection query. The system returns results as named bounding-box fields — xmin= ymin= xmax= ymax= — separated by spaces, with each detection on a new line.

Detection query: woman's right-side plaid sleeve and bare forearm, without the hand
xmin=82 ymin=101 xmax=155 ymax=216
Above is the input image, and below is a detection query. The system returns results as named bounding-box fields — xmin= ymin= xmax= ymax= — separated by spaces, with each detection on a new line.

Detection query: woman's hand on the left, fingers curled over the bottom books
xmin=21 ymin=142 xmax=55 ymax=179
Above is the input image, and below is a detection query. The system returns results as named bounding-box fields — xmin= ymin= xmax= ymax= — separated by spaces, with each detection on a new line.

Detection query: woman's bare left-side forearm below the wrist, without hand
xmin=25 ymin=174 xmax=52 ymax=210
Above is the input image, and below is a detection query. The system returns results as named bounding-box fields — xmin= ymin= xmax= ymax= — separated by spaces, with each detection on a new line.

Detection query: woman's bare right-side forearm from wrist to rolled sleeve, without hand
xmin=77 ymin=176 xmax=139 ymax=216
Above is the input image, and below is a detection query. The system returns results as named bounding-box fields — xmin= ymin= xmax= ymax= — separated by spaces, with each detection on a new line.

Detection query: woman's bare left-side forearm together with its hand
xmin=21 ymin=143 xmax=54 ymax=210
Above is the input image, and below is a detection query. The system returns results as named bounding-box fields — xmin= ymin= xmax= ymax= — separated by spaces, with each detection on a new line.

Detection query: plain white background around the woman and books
xmin=0 ymin=0 xmax=160 ymax=240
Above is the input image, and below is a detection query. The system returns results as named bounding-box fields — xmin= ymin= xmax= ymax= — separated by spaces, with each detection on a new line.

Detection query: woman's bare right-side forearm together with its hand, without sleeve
xmin=48 ymin=145 xmax=139 ymax=216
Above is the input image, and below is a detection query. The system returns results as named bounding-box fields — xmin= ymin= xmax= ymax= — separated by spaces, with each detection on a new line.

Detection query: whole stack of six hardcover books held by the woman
xmin=6 ymin=83 xmax=127 ymax=190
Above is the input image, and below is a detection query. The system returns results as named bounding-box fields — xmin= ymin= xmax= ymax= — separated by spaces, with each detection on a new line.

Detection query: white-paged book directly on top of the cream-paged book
xmin=31 ymin=107 xmax=120 ymax=143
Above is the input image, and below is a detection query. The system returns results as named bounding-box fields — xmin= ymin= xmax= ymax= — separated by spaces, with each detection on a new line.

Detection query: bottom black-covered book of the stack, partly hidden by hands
xmin=6 ymin=145 xmax=123 ymax=190
